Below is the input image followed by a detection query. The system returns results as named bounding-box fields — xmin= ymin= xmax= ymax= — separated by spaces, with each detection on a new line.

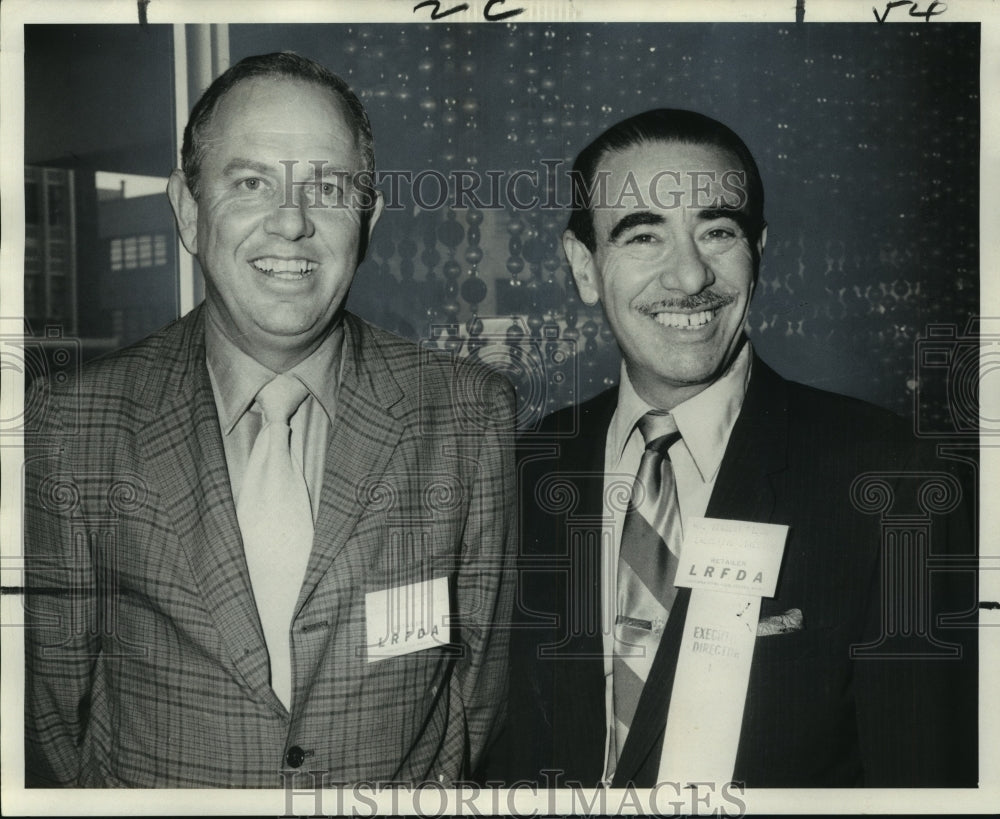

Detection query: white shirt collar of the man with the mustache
xmin=608 ymin=341 xmax=751 ymax=481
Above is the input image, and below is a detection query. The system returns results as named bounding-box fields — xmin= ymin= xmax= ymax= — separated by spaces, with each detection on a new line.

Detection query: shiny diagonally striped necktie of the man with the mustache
xmin=612 ymin=411 xmax=681 ymax=760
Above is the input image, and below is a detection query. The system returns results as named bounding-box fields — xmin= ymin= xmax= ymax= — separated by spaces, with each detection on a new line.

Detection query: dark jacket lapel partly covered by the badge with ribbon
xmin=613 ymin=355 xmax=788 ymax=787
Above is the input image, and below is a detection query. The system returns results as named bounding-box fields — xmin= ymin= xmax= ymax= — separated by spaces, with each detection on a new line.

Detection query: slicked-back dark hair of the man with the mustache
xmin=568 ymin=108 xmax=765 ymax=255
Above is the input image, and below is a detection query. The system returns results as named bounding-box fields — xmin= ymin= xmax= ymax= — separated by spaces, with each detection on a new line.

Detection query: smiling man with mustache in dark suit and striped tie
xmin=487 ymin=109 xmax=976 ymax=788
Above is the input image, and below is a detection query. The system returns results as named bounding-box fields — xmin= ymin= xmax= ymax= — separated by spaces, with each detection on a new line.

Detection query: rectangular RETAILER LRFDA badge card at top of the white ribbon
xmin=675 ymin=518 xmax=788 ymax=597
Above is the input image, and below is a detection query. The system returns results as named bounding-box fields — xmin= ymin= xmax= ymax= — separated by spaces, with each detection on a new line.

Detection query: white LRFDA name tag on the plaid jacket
xmin=365 ymin=577 xmax=451 ymax=663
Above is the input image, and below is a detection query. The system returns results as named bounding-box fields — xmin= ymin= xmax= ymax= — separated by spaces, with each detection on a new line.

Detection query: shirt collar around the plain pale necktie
xmin=205 ymin=310 xmax=344 ymax=435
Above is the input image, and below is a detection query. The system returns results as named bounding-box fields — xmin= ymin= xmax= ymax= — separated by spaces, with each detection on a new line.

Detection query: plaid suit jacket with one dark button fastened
xmin=25 ymin=309 xmax=515 ymax=787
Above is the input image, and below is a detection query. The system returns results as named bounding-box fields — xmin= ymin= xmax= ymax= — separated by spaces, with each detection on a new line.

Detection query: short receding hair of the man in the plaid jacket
xmin=181 ymin=51 xmax=375 ymax=199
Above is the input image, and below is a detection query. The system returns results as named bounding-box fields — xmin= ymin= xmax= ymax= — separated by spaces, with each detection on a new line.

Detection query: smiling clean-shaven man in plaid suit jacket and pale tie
xmin=25 ymin=54 xmax=514 ymax=787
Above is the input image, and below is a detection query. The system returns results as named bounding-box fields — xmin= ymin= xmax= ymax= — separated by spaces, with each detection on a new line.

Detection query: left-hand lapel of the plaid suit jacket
xmin=137 ymin=310 xmax=270 ymax=696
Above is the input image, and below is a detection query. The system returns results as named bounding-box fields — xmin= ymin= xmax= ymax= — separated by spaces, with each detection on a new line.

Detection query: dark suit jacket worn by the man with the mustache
xmin=486 ymin=358 xmax=977 ymax=787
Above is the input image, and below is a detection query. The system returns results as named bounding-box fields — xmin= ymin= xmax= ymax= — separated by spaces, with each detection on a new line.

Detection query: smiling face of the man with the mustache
xmin=563 ymin=128 xmax=767 ymax=410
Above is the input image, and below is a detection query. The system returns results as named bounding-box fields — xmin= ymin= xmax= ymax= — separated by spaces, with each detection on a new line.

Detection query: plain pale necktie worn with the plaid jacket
xmin=236 ymin=375 xmax=313 ymax=709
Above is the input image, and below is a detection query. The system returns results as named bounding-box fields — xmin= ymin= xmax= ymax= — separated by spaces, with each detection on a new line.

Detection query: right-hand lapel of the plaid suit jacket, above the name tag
xmin=299 ymin=314 xmax=403 ymax=607
